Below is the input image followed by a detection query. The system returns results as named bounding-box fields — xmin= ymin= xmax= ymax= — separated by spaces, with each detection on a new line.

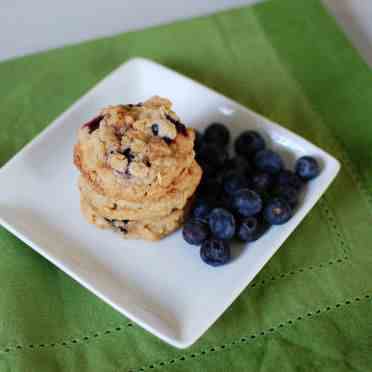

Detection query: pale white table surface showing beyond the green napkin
xmin=0 ymin=0 xmax=372 ymax=66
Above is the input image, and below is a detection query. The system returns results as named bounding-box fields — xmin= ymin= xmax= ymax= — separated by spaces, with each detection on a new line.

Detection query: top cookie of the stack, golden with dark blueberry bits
xmin=74 ymin=96 xmax=195 ymax=201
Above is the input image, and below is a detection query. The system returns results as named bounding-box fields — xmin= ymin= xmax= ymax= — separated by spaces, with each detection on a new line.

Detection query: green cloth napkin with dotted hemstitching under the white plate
xmin=0 ymin=0 xmax=372 ymax=372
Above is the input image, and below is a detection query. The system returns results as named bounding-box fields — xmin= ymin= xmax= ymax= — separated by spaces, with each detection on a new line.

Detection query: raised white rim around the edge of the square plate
xmin=0 ymin=57 xmax=341 ymax=349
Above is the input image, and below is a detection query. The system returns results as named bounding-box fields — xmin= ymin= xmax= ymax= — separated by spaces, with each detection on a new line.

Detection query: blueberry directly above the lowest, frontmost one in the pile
xmin=208 ymin=208 xmax=235 ymax=240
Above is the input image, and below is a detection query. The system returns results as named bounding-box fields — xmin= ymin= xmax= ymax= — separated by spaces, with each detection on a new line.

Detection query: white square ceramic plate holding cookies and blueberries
xmin=0 ymin=58 xmax=340 ymax=348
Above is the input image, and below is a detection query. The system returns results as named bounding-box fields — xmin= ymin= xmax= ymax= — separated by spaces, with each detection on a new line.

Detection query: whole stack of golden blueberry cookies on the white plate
xmin=74 ymin=97 xmax=202 ymax=240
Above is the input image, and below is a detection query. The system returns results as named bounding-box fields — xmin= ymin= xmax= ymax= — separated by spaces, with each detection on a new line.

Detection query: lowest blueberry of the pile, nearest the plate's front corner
xmin=200 ymin=239 xmax=231 ymax=266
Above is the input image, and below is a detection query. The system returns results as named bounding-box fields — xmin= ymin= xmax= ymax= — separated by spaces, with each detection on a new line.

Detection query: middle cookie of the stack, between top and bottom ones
xmin=79 ymin=161 xmax=201 ymax=220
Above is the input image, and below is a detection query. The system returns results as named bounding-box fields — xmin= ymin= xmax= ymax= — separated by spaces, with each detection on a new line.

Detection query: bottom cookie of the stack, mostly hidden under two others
xmin=80 ymin=197 xmax=189 ymax=240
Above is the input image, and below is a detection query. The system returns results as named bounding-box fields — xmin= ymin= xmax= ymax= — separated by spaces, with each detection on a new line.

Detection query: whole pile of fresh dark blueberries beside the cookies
xmin=183 ymin=123 xmax=320 ymax=266
